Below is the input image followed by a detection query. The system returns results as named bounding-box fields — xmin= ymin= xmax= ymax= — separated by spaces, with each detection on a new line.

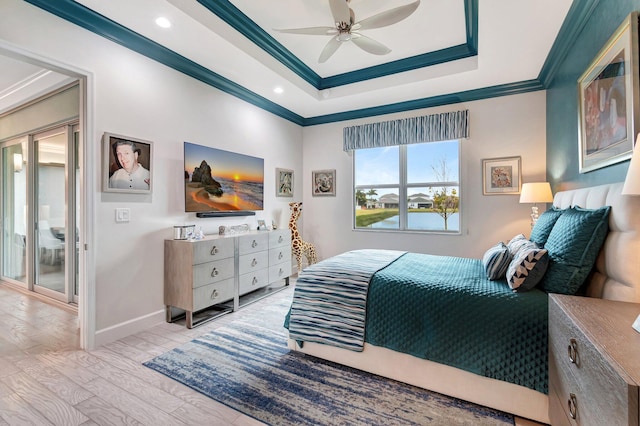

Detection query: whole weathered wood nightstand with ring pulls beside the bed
xmin=549 ymin=294 xmax=640 ymax=426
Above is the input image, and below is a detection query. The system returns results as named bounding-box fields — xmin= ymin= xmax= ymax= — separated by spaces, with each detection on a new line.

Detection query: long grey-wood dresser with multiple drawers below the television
xmin=164 ymin=229 xmax=291 ymax=328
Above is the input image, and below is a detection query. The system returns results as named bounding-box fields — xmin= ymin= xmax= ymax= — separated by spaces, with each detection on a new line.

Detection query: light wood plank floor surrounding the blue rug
xmin=0 ymin=285 xmax=538 ymax=426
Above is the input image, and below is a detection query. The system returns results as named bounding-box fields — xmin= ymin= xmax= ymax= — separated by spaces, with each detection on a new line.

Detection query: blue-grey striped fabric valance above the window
xmin=343 ymin=110 xmax=469 ymax=151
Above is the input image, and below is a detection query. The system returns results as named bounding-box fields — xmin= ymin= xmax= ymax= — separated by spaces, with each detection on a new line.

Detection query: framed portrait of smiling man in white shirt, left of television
xmin=102 ymin=133 xmax=153 ymax=194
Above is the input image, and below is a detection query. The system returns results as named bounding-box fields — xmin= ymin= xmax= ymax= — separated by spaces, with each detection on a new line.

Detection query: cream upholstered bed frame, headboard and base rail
xmin=289 ymin=183 xmax=640 ymax=424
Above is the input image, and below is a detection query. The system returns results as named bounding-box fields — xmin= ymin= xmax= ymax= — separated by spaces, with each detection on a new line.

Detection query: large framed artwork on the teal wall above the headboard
xmin=578 ymin=12 xmax=640 ymax=173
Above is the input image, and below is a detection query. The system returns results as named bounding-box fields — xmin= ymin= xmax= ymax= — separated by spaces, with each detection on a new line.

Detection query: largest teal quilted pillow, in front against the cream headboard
xmin=542 ymin=206 xmax=611 ymax=294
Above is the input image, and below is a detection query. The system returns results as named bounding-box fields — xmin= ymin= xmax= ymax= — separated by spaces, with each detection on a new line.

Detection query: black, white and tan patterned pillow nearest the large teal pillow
xmin=506 ymin=242 xmax=549 ymax=292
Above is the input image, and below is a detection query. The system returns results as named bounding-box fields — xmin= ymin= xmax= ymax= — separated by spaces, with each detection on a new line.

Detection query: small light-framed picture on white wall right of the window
xmin=482 ymin=157 xmax=521 ymax=195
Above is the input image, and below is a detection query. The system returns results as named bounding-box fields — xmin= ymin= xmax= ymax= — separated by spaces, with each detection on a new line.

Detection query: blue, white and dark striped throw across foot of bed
xmin=288 ymin=249 xmax=406 ymax=351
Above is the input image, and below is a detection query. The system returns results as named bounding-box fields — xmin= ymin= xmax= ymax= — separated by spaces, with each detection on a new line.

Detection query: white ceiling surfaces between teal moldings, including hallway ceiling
xmin=0 ymin=0 xmax=572 ymax=118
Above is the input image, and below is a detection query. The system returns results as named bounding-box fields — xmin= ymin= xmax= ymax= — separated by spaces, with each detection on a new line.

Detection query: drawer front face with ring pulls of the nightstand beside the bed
xmin=549 ymin=303 xmax=638 ymax=425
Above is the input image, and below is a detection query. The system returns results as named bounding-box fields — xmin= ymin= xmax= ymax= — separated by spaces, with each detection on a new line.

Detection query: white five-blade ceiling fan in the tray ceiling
xmin=275 ymin=0 xmax=420 ymax=63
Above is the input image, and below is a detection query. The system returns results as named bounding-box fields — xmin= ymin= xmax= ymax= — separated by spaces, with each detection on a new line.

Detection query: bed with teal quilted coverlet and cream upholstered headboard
xmin=287 ymin=183 xmax=640 ymax=423
